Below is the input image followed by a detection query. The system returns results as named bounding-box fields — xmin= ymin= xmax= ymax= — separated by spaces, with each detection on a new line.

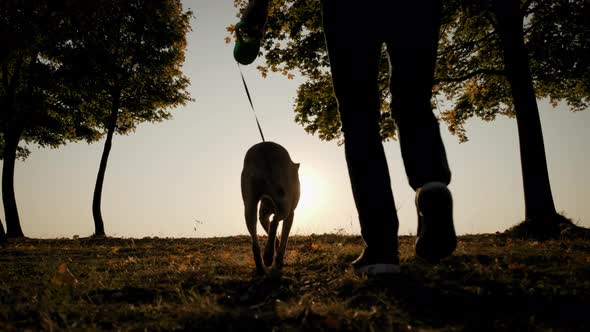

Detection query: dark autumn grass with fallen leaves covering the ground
xmin=0 ymin=235 xmax=590 ymax=331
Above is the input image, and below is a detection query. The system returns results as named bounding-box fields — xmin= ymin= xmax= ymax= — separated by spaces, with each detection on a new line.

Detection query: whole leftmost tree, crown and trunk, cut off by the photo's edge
xmin=0 ymin=0 xmax=100 ymax=238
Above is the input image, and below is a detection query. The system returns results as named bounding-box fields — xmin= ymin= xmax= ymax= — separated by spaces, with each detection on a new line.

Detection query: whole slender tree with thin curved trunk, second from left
xmin=67 ymin=0 xmax=192 ymax=237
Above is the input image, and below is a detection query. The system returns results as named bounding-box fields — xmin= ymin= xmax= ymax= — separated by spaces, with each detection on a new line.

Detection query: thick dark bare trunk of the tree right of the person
xmin=494 ymin=0 xmax=557 ymax=223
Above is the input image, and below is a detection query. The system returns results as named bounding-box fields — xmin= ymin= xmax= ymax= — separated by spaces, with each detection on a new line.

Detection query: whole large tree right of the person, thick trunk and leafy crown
xmin=438 ymin=0 xmax=590 ymax=238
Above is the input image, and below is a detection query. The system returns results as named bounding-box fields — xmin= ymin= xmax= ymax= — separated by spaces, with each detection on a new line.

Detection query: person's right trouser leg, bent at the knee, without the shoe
xmin=387 ymin=1 xmax=451 ymax=190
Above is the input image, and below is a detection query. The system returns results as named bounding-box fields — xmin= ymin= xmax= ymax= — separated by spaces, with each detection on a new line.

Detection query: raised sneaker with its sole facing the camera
xmin=416 ymin=182 xmax=457 ymax=262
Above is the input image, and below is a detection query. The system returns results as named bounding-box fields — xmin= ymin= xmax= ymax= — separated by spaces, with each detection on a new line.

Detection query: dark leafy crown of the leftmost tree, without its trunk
xmin=0 ymin=0 xmax=96 ymax=159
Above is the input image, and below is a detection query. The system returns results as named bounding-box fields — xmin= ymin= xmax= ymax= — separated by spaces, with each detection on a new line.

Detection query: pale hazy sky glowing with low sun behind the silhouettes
xmin=0 ymin=0 xmax=590 ymax=238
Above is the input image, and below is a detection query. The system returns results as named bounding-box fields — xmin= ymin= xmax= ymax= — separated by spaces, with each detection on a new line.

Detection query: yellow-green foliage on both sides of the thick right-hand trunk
xmin=435 ymin=0 xmax=590 ymax=141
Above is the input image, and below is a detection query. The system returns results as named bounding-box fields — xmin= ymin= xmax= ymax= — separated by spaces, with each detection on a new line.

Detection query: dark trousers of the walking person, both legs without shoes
xmin=322 ymin=0 xmax=451 ymax=253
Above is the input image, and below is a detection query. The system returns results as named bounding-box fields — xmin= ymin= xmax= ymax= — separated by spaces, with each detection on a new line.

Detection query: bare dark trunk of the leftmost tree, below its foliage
xmin=2 ymin=125 xmax=25 ymax=238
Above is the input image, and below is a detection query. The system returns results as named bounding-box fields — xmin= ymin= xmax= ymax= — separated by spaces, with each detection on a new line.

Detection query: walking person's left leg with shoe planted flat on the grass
xmin=322 ymin=0 xmax=399 ymax=274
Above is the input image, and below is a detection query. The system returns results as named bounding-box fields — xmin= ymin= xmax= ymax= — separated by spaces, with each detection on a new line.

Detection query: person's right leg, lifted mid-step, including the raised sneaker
xmin=387 ymin=2 xmax=456 ymax=261
